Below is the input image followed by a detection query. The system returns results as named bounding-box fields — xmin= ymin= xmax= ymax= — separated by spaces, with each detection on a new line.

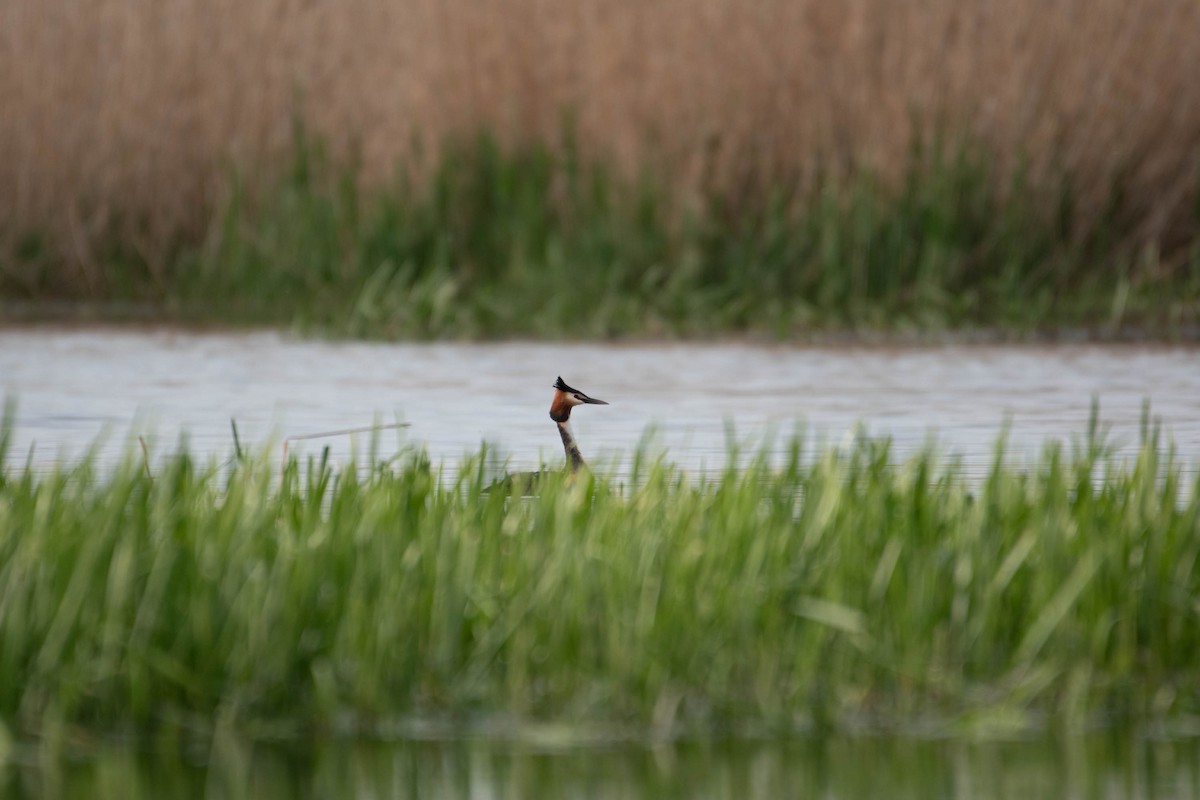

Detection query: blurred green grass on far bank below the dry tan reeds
xmin=21 ymin=134 xmax=1200 ymax=338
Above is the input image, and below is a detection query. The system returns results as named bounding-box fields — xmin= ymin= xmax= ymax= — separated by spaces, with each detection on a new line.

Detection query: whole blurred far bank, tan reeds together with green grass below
xmin=0 ymin=0 xmax=1200 ymax=337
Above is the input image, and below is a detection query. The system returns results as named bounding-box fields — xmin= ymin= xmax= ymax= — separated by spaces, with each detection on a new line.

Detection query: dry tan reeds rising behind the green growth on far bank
xmin=0 ymin=0 xmax=1200 ymax=287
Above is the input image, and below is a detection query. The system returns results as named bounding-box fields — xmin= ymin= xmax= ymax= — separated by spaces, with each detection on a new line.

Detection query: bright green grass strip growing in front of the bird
xmin=0 ymin=412 xmax=1200 ymax=736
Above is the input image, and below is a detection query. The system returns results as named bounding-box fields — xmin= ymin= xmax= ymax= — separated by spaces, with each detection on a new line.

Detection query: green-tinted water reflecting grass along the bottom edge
xmin=7 ymin=736 xmax=1200 ymax=800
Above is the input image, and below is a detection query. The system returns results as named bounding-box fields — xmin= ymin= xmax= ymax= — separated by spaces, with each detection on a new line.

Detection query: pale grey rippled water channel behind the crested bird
xmin=0 ymin=329 xmax=1200 ymax=479
